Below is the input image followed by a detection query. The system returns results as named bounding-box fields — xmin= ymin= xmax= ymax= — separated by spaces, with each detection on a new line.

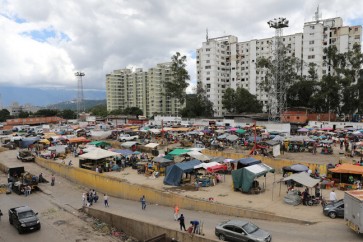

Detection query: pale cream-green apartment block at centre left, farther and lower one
xmin=106 ymin=63 xmax=184 ymax=117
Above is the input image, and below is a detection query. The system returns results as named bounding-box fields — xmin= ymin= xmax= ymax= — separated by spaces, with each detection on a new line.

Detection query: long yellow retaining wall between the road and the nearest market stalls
xmin=36 ymin=158 xmax=309 ymax=224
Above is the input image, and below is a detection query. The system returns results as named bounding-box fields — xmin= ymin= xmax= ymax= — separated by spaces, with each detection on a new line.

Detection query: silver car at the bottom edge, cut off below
xmin=215 ymin=220 xmax=272 ymax=242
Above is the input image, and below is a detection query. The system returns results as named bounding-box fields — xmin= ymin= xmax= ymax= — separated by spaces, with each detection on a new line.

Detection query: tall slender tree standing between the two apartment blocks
xmin=165 ymin=52 xmax=190 ymax=104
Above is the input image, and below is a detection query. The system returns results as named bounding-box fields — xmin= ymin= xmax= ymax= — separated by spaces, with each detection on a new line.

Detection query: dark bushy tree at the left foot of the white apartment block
xmin=180 ymin=85 xmax=214 ymax=118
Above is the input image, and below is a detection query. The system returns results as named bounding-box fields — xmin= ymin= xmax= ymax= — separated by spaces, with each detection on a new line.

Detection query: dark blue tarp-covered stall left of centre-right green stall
xmin=164 ymin=160 xmax=202 ymax=186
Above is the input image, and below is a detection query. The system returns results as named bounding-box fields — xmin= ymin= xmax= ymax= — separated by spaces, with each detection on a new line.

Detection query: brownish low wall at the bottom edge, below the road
xmin=84 ymin=208 xmax=218 ymax=242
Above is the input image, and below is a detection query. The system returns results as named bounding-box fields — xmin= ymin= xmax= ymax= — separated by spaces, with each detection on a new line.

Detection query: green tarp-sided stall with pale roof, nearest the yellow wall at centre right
xmin=232 ymin=163 xmax=275 ymax=192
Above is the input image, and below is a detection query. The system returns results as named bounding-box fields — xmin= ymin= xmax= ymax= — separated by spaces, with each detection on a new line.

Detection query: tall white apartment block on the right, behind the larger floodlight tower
xmin=197 ymin=17 xmax=362 ymax=116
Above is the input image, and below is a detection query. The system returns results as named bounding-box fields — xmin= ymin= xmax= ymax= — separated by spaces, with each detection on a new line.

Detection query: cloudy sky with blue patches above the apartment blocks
xmin=0 ymin=0 xmax=363 ymax=102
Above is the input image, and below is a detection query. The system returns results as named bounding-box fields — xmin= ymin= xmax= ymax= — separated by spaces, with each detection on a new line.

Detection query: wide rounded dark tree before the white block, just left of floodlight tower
xmin=222 ymin=87 xmax=262 ymax=113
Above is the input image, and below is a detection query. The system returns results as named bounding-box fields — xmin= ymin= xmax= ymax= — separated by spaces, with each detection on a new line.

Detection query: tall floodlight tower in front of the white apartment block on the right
xmin=267 ymin=18 xmax=289 ymax=121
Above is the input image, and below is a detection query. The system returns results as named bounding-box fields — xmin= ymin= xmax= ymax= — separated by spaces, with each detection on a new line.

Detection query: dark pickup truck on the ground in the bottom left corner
xmin=9 ymin=206 xmax=40 ymax=234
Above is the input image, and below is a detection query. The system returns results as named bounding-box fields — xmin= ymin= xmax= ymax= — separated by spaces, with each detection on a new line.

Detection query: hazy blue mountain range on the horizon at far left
xmin=0 ymin=86 xmax=106 ymax=108
